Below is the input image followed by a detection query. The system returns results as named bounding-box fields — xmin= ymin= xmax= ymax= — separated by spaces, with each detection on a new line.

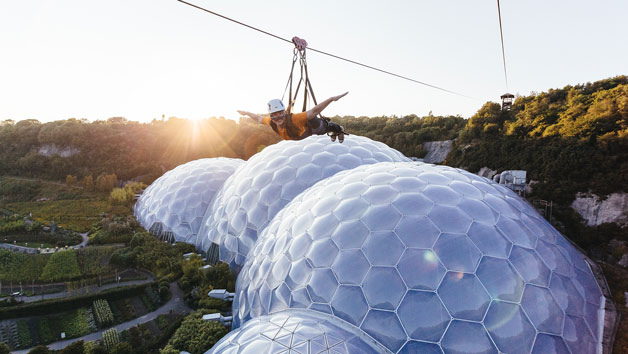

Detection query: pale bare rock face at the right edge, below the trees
xmin=571 ymin=193 xmax=628 ymax=226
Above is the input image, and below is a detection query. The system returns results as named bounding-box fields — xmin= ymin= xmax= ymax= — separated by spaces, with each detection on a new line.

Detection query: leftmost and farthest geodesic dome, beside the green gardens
xmin=133 ymin=157 xmax=244 ymax=250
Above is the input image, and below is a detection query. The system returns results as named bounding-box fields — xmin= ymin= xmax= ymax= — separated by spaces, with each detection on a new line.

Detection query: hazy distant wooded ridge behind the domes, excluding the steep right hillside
xmin=0 ymin=115 xmax=465 ymax=184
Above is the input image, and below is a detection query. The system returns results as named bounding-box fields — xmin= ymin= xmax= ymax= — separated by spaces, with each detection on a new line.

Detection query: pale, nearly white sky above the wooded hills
xmin=0 ymin=0 xmax=628 ymax=121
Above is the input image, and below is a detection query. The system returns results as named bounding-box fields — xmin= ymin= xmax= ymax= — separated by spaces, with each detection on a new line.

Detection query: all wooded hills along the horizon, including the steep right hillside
xmin=0 ymin=76 xmax=628 ymax=202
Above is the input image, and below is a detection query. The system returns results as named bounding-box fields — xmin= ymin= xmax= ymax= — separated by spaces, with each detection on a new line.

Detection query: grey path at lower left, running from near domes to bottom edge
xmin=11 ymin=282 xmax=192 ymax=354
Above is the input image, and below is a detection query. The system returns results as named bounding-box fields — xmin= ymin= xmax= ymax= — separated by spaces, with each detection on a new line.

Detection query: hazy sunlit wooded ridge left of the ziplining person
xmin=0 ymin=117 xmax=279 ymax=182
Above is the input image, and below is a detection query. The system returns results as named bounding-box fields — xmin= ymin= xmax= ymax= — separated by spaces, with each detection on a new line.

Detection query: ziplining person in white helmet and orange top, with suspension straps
xmin=238 ymin=37 xmax=349 ymax=143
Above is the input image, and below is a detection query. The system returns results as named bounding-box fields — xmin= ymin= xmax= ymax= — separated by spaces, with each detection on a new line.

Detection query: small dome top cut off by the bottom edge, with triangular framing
xmin=207 ymin=310 xmax=387 ymax=354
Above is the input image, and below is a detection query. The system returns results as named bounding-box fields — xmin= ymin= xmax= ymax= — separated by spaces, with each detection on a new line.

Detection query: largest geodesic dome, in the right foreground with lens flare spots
xmin=233 ymin=163 xmax=605 ymax=353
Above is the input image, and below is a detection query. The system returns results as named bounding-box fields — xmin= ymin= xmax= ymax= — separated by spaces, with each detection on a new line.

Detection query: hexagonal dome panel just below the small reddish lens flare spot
xmin=437 ymin=272 xmax=491 ymax=321
